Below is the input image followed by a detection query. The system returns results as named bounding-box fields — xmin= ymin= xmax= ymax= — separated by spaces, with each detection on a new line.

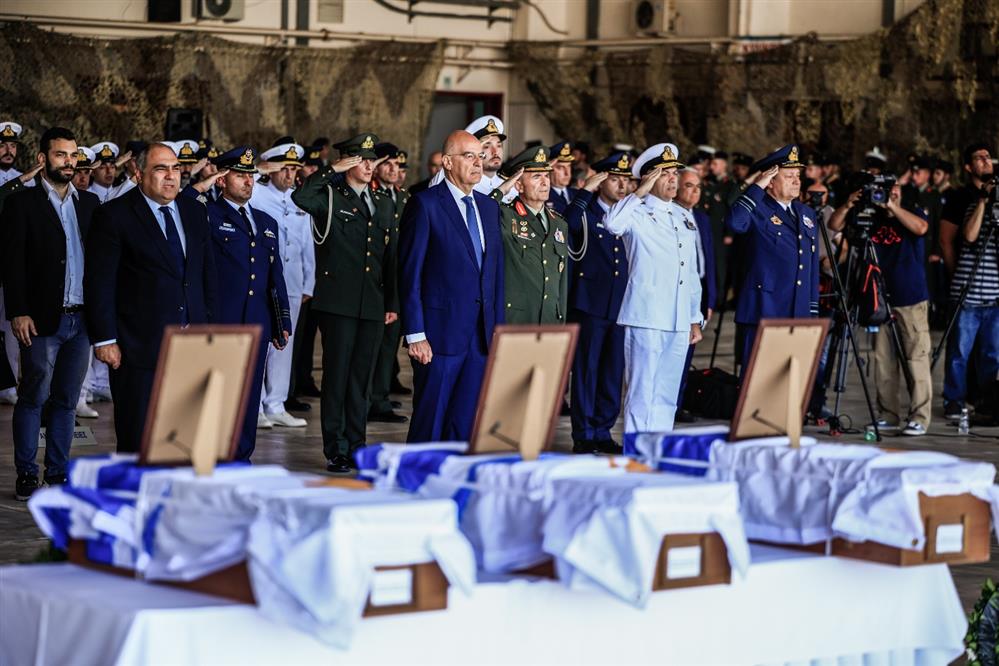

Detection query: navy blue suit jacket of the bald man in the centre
xmin=399 ymin=183 xmax=504 ymax=355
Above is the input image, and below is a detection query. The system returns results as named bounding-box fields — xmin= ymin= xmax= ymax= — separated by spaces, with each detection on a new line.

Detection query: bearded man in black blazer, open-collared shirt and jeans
xmin=0 ymin=127 xmax=100 ymax=500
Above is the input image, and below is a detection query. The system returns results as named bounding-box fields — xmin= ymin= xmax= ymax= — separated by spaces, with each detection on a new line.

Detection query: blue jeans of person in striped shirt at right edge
xmin=944 ymin=305 xmax=999 ymax=403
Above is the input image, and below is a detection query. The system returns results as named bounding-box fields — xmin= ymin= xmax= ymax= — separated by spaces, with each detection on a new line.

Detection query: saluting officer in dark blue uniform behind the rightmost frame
xmin=725 ymin=145 xmax=821 ymax=370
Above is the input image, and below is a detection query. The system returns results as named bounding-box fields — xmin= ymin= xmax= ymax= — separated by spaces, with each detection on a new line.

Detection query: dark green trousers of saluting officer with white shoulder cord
xmin=313 ymin=310 xmax=385 ymax=460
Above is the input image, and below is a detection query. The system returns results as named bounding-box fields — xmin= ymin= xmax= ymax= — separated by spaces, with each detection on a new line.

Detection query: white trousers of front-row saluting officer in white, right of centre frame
xmin=624 ymin=326 xmax=690 ymax=433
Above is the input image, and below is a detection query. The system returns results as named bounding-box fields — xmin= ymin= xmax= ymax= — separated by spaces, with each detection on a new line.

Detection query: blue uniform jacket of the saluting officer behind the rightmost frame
xmin=725 ymin=185 xmax=819 ymax=324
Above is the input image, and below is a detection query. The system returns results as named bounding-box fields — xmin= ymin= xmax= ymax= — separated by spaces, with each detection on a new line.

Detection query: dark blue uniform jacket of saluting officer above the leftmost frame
xmin=207 ymin=199 xmax=291 ymax=343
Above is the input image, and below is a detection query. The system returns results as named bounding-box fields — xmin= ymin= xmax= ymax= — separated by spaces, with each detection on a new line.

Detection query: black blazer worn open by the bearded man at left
xmin=0 ymin=185 xmax=100 ymax=336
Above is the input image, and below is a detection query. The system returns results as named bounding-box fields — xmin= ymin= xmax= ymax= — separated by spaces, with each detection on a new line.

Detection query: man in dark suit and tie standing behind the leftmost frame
xmin=84 ymin=143 xmax=216 ymax=452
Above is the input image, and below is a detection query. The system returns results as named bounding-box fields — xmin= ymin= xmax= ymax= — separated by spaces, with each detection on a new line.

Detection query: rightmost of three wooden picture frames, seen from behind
xmin=729 ymin=319 xmax=829 ymax=446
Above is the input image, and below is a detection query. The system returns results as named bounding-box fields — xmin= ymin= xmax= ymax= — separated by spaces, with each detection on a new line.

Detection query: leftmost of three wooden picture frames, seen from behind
xmin=139 ymin=325 xmax=260 ymax=475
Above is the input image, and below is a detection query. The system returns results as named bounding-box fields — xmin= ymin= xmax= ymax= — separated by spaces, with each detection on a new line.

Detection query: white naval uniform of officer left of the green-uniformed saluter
xmin=250 ymin=182 xmax=316 ymax=414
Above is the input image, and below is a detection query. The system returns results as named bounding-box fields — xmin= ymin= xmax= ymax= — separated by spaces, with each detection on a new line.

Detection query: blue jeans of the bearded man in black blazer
xmin=14 ymin=312 xmax=90 ymax=478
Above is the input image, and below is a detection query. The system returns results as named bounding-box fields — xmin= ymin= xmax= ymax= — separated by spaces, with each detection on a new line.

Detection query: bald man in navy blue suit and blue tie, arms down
xmin=399 ymin=130 xmax=503 ymax=442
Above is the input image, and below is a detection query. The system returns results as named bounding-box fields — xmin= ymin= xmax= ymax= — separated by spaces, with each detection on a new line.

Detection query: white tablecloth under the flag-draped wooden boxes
xmin=0 ymin=547 xmax=966 ymax=666
